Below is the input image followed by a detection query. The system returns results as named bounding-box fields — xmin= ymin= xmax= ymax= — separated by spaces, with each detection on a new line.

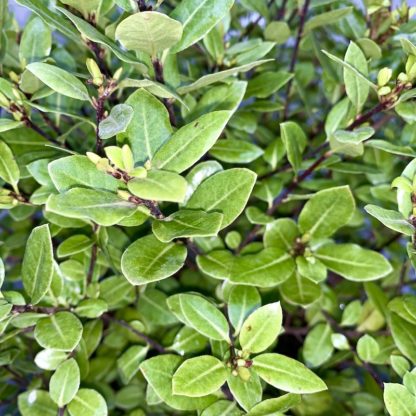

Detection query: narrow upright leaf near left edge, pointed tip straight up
xmin=22 ymin=224 xmax=53 ymax=305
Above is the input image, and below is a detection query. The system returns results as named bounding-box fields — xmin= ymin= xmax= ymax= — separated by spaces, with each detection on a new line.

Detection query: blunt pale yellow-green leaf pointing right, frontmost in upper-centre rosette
xmin=127 ymin=170 xmax=187 ymax=202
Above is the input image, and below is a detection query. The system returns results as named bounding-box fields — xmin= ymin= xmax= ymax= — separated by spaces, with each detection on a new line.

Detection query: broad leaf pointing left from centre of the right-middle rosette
xmin=230 ymin=247 xmax=295 ymax=287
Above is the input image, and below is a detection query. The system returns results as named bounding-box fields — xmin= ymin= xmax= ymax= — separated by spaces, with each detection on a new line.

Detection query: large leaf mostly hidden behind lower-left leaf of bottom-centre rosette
xmin=140 ymin=354 xmax=218 ymax=411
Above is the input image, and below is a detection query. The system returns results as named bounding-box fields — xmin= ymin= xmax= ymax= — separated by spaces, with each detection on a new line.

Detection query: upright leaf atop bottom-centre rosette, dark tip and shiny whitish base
xmin=227 ymin=285 xmax=261 ymax=334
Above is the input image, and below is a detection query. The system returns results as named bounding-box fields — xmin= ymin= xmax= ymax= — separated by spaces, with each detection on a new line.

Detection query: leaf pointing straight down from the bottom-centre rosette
xmin=227 ymin=368 xmax=263 ymax=411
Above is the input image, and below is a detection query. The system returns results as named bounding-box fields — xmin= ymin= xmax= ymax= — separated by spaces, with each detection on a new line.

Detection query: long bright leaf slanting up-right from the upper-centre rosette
xmin=152 ymin=111 xmax=231 ymax=173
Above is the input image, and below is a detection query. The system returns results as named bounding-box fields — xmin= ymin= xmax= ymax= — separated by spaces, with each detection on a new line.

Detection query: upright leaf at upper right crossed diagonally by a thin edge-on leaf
xmin=344 ymin=42 xmax=370 ymax=112
